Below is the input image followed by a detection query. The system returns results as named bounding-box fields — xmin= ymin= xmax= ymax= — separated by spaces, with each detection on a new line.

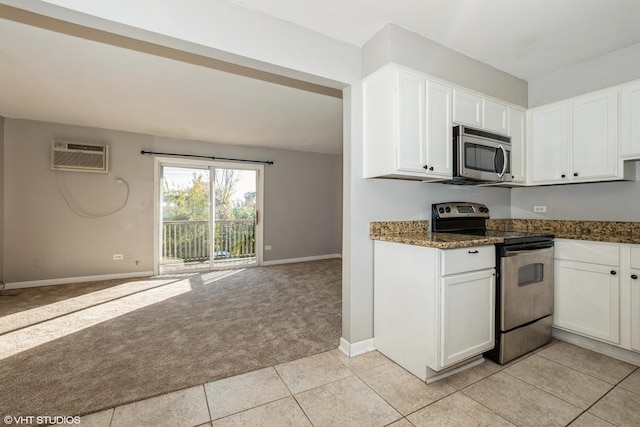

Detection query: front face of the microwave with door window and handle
xmin=456 ymin=135 xmax=511 ymax=182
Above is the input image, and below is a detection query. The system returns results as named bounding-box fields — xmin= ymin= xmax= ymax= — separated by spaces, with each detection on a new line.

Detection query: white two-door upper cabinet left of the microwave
xmin=364 ymin=65 xmax=453 ymax=180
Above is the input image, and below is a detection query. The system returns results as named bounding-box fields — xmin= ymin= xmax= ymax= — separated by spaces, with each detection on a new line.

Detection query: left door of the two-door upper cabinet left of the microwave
xmin=395 ymin=69 xmax=426 ymax=173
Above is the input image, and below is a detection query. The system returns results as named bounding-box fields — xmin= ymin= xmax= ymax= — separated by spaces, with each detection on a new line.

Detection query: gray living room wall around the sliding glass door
xmin=3 ymin=119 xmax=342 ymax=282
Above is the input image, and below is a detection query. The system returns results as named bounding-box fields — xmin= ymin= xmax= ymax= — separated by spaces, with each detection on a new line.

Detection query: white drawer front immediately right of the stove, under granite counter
xmin=554 ymin=239 xmax=620 ymax=267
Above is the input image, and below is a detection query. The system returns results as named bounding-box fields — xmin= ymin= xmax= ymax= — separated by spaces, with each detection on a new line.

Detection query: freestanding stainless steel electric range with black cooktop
xmin=431 ymin=202 xmax=553 ymax=364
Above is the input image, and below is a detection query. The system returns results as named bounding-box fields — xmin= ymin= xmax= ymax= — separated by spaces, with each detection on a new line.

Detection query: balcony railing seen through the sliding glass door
xmin=162 ymin=219 xmax=256 ymax=264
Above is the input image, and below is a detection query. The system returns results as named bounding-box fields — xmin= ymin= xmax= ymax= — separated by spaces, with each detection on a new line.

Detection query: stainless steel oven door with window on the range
xmin=500 ymin=243 xmax=553 ymax=332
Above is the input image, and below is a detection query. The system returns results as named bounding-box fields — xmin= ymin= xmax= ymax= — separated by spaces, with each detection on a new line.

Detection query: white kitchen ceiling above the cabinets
xmin=232 ymin=0 xmax=640 ymax=81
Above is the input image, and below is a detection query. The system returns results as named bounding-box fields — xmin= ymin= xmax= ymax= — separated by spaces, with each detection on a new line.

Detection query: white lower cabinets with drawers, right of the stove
xmin=553 ymin=239 xmax=640 ymax=352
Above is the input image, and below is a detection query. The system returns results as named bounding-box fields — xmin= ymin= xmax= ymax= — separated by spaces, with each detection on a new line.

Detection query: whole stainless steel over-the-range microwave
xmin=444 ymin=125 xmax=512 ymax=185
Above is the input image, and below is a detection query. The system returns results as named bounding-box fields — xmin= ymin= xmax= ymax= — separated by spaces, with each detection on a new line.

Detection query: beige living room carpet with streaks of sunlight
xmin=0 ymin=259 xmax=341 ymax=417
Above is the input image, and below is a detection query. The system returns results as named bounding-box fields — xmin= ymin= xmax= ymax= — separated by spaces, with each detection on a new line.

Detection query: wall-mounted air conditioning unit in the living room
xmin=51 ymin=141 xmax=109 ymax=173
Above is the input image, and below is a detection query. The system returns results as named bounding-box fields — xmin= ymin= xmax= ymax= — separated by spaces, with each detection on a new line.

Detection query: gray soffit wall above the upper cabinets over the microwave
xmin=362 ymin=24 xmax=528 ymax=107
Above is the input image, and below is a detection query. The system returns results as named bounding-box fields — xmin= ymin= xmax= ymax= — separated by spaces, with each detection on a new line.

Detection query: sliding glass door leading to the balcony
xmin=157 ymin=161 xmax=262 ymax=274
